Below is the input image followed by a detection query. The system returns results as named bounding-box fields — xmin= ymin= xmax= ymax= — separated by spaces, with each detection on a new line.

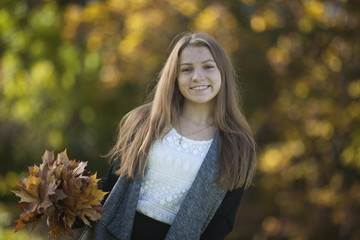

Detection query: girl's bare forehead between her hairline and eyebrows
xmin=180 ymin=46 xmax=214 ymax=63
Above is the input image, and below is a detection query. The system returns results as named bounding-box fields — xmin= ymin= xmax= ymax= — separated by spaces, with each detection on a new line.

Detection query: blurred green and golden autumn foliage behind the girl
xmin=0 ymin=0 xmax=360 ymax=240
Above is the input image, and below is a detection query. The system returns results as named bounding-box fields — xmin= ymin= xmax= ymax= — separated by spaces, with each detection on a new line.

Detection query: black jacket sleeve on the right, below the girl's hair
xmin=200 ymin=187 xmax=244 ymax=240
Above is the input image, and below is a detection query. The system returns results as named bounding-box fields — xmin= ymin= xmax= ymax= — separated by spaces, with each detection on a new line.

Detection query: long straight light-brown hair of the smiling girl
xmin=108 ymin=33 xmax=256 ymax=190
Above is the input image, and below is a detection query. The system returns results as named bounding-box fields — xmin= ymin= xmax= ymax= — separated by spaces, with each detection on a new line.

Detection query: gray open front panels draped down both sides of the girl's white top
xmin=79 ymin=136 xmax=226 ymax=240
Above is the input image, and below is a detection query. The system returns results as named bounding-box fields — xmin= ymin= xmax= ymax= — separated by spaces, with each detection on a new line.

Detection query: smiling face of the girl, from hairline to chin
xmin=177 ymin=46 xmax=221 ymax=107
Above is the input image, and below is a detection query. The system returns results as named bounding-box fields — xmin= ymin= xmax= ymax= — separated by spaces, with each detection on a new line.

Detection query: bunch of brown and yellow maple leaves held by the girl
xmin=13 ymin=150 xmax=106 ymax=239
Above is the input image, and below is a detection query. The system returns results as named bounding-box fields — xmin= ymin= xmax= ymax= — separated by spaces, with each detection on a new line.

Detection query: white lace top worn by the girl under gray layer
xmin=137 ymin=128 xmax=212 ymax=224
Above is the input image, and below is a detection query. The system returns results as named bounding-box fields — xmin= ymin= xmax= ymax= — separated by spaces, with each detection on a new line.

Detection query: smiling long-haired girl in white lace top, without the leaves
xmin=83 ymin=33 xmax=256 ymax=239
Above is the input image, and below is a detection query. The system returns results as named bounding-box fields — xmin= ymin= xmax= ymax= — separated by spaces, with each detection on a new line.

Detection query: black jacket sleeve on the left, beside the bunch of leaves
xmin=71 ymin=158 xmax=120 ymax=229
